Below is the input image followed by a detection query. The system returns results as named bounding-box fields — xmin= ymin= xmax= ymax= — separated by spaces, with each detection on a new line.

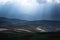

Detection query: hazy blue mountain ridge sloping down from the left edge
xmin=0 ymin=17 xmax=27 ymax=24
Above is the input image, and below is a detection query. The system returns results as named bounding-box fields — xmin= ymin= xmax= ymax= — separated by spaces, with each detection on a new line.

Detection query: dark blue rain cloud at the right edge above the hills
xmin=51 ymin=4 xmax=60 ymax=20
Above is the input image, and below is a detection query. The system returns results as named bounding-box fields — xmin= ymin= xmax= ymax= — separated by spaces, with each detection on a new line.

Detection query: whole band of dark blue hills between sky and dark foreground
xmin=0 ymin=17 xmax=60 ymax=31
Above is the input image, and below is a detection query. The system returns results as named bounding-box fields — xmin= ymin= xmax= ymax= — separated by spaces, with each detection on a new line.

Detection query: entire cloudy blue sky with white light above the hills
xmin=0 ymin=0 xmax=60 ymax=21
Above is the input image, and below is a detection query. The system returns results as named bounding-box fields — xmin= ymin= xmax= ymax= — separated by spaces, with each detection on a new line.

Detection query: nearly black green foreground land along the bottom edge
xmin=0 ymin=32 xmax=60 ymax=40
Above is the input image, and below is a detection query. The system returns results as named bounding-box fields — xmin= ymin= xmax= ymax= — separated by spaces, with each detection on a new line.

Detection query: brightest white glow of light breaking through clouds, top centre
xmin=14 ymin=0 xmax=39 ymax=15
